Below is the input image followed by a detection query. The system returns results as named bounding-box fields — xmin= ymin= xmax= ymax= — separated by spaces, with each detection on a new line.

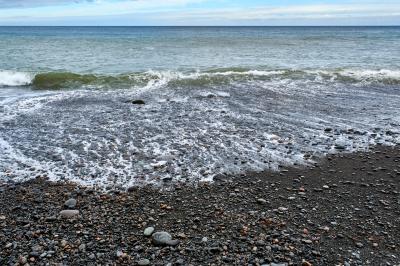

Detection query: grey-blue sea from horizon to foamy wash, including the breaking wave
xmin=0 ymin=27 xmax=400 ymax=189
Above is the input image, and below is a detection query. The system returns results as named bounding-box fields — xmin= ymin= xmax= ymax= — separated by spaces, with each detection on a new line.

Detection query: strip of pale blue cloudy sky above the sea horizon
xmin=0 ymin=0 xmax=400 ymax=26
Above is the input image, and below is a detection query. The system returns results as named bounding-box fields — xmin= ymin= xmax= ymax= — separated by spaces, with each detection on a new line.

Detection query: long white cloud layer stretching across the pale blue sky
xmin=0 ymin=0 xmax=400 ymax=25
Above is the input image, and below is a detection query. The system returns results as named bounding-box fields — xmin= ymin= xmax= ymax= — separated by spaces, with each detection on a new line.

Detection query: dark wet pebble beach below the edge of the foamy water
xmin=0 ymin=146 xmax=400 ymax=265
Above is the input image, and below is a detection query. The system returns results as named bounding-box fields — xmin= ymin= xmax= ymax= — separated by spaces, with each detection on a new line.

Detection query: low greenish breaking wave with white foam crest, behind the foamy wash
xmin=0 ymin=68 xmax=400 ymax=89
